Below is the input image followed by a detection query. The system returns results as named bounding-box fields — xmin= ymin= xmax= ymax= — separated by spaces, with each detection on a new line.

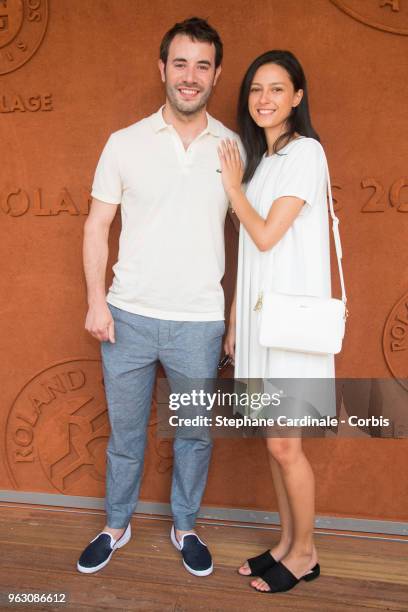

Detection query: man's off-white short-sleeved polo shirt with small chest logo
xmin=92 ymin=108 xmax=237 ymax=321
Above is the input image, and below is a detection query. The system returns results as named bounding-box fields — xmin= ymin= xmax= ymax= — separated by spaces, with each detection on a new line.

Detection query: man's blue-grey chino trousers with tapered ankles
xmin=101 ymin=304 xmax=225 ymax=531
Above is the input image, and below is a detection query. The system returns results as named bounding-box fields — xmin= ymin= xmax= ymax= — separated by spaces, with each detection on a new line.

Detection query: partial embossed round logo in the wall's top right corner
xmin=331 ymin=0 xmax=408 ymax=36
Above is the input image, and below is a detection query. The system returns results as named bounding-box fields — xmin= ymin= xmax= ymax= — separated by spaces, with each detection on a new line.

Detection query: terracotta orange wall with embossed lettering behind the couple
xmin=0 ymin=0 xmax=408 ymax=520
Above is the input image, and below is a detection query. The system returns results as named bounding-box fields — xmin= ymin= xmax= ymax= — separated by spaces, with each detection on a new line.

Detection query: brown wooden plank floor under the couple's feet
xmin=0 ymin=504 xmax=408 ymax=612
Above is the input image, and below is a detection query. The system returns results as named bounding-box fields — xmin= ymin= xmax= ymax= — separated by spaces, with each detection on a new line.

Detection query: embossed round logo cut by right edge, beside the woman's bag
xmin=383 ymin=293 xmax=408 ymax=391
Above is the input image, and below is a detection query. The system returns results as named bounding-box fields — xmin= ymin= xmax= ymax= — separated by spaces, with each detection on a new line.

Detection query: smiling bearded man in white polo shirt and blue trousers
xmin=77 ymin=18 xmax=239 ymax=576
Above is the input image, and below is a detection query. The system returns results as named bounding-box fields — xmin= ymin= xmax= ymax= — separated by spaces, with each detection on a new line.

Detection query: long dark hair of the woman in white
xmin=238 ymin=50 xmax=320 ymax=183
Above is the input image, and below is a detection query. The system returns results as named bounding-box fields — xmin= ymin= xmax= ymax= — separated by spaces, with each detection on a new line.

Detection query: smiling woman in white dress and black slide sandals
xmin=219 ymin=51 xmax=334 ymax=592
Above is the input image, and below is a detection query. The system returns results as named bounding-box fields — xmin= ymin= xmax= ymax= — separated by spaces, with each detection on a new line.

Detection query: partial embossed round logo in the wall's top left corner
xmin=0 ymin=0 xmax=48 ymax=74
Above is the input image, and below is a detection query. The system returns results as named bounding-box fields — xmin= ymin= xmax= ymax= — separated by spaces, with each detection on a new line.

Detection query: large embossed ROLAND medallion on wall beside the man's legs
xmin=6 ymin=359 xmax=110 ymax=495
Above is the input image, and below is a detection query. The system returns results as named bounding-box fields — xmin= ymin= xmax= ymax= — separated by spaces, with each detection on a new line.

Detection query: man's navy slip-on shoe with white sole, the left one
xmin=77 ymin=523 xmax=131 ymax=574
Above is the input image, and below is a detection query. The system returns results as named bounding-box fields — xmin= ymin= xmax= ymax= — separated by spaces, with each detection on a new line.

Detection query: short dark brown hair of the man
xmin=160 ymin=17 xmax=223 ymax=68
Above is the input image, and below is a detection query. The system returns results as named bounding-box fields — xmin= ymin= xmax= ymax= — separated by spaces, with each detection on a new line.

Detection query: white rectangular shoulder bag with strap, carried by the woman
xmin=254 ymin=163 xmax=348 ymax=355
